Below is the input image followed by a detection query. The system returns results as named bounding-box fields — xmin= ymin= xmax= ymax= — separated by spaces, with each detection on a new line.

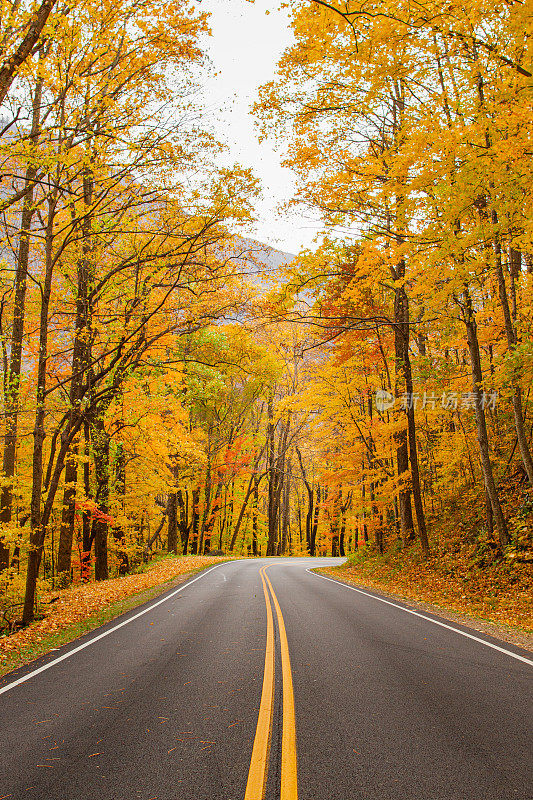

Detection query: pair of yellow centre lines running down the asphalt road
xmin=244 ymin=565 xmax=298 ymax=800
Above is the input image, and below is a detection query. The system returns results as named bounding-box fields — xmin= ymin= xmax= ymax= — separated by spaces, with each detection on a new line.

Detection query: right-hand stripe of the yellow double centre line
xmin=263 ymin=567 xmax=298 ymax=800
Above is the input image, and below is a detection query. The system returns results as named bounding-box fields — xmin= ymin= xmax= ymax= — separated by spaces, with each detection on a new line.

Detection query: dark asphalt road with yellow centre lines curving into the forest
xmin=0 ymin=559 xmax=533 ymax=800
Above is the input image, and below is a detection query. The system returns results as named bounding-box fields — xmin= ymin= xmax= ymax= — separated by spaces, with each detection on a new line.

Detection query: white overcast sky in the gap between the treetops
xmin=197 ymin=0 xmax=320 ymax=253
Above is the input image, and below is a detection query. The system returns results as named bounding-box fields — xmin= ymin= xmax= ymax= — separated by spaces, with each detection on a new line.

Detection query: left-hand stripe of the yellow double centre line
xmin=244 ymin=567 xmax=275 ymax=800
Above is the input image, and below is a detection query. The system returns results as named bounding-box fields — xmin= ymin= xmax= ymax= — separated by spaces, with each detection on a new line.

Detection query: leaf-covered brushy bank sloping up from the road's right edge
xmin=330 ymin=487 xmax=533 ymax=631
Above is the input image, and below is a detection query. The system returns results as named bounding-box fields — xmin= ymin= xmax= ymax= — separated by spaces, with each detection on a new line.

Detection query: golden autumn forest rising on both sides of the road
xmin=0 ymin=0 xmax=533 ymax=636
